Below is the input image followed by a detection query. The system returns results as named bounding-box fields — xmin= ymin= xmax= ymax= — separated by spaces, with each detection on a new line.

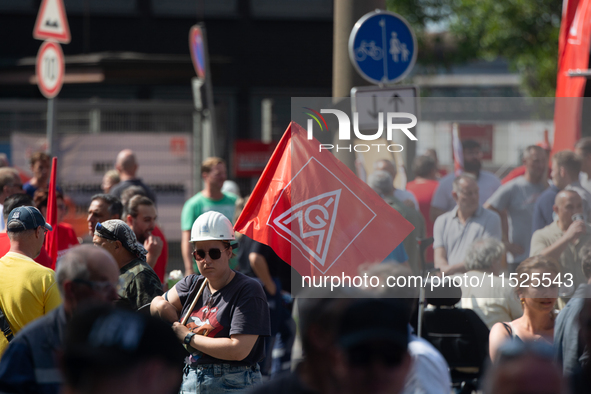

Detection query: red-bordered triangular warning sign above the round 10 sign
xmin=33 ymin=0 xmax=71 ymax=44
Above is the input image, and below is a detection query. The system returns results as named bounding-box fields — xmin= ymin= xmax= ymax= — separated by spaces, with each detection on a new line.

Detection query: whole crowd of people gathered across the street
xmin=0 ymin=138 xmax=591 ymax=393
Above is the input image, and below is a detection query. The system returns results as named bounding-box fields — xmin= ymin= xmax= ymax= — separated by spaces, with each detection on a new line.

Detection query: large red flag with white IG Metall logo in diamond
xmin=234 ymin=122 xmax=413 ymax=276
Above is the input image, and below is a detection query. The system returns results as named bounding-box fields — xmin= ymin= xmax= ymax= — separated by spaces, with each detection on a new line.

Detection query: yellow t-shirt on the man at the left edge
xmin=0 ymin=252 xmax=62 ymax=357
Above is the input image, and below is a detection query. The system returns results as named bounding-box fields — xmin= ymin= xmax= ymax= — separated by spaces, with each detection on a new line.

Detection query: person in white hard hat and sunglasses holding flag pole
xmin=151 ymin=211 xmax=271 ymax=393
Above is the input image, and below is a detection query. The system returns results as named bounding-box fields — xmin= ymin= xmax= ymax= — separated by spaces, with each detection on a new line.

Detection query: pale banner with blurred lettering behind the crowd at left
xmin=11 ymin=133 xmax=193 ymax=241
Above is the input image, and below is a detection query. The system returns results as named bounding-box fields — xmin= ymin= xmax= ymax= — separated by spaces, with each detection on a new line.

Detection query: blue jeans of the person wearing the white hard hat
xmin=180 ymin=364 xmax=261 ymax=394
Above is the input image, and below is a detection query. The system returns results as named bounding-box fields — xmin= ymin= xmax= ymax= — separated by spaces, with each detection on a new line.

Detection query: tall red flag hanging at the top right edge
xmin=552 ymin=0 xmax=591 ymax=152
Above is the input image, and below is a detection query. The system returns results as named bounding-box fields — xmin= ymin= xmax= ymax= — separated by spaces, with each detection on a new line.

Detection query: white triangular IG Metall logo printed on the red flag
xmin=273 ymin=189 xmax=341 ymax=267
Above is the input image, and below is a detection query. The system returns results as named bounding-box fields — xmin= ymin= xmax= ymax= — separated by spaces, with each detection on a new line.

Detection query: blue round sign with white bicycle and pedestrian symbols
xmin=349 ymin=10 xmax=418 ymax=84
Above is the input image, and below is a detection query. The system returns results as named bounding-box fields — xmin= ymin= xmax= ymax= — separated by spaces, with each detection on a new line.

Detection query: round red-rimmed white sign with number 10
xmin=35 ymin=41 xmax=65 ymax=99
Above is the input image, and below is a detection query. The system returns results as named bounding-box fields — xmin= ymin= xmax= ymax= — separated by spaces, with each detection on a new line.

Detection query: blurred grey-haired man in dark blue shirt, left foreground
xmin=0 ymin=245 xmax=118 ymax=394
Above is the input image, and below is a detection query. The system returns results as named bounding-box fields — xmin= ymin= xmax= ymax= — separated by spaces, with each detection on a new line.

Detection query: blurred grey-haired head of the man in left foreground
xmin=56 ymin=245 xmax=119 ymax=312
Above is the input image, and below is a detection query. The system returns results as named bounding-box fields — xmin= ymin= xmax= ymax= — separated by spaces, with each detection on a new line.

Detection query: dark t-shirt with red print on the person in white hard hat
xmin=175 ymin=272 xmax=271 ymax=365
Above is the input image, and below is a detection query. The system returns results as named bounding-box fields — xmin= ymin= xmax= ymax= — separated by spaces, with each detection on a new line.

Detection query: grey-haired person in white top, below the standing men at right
xmin=456 ymin=238 xmax=523 ymax=329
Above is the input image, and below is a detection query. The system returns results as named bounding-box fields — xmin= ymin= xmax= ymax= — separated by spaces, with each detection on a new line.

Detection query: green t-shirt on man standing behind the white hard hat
xmin=181 ymin=192 xmax=238 ymax=231
